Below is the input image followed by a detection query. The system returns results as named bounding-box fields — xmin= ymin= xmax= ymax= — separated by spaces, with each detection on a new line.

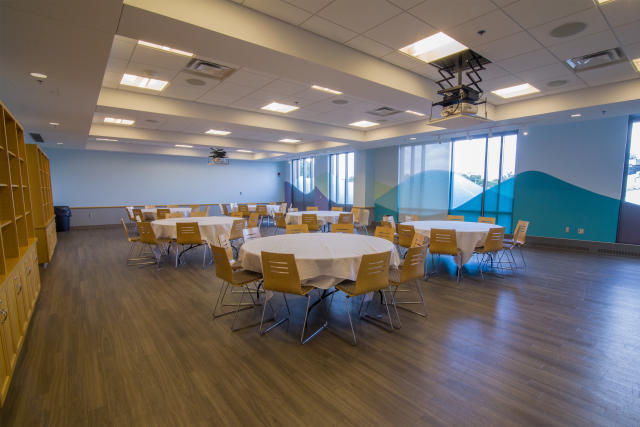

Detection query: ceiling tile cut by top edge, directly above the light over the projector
xmin=409 ymin=0 xmax=496 ymax=30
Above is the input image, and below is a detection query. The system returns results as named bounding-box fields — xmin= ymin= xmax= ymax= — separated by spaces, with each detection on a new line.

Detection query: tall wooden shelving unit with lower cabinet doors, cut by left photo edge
xmin=0 ymin=103 xmax=40 ymax=405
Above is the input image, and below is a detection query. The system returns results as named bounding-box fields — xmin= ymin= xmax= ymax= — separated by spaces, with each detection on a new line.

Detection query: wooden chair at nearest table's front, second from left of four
xmin=259 ymin=251 xmax=329 ymax=344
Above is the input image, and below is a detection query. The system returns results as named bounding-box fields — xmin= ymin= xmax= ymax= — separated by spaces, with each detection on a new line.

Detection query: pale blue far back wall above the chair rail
xmin=46 ymin=149 xmax=285 ymax=206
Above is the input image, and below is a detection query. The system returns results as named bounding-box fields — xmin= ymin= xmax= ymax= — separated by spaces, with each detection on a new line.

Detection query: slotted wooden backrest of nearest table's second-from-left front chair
xmin=261 ymin=251 xmax=302 ymax=295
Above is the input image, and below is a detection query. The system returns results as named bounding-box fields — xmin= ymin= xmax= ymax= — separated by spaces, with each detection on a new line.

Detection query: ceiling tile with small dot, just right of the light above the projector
xmin=447 ymin=10 xmax=522 ymax=48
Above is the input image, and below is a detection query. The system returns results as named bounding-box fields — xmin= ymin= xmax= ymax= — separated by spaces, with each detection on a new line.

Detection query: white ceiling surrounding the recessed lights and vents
xmin=0 ymin=0 xmax=640 ymax=160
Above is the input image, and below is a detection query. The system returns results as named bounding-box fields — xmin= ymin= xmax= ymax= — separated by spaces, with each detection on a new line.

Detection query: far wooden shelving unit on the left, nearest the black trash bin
xmin=26 ymin=144 xmax=57 ymax=264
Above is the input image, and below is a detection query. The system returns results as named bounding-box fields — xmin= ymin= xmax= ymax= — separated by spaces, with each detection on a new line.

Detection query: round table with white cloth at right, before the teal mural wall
xmin=402 ymin=221 xmax=501 ymax=265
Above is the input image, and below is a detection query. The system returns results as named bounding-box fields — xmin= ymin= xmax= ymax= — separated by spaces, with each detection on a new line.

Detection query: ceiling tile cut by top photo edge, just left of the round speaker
xmin=504 ymin=0 xmax=595 ymax=28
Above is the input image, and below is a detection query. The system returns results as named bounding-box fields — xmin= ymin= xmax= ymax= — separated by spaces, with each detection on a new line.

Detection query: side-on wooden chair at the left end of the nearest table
xmin=210 ymin=245 xmax=261 ymax=331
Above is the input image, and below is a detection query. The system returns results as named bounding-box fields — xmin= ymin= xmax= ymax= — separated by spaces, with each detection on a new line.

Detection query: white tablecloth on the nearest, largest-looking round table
xmin=238 ymin=233 xmax=400 ymax=289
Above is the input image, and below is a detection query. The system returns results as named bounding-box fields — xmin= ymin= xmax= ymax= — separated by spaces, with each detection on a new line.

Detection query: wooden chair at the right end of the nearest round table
xmin=389 ymin=246 xmax=427 ymax=326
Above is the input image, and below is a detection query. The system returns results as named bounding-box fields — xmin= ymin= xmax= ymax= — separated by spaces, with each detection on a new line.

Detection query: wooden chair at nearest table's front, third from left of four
xmin=332 ymin=252 xmax=393 ymax=345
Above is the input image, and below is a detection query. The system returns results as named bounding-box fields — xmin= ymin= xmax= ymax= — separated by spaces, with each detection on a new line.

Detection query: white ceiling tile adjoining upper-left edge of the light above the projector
xmin=364 ymin=13 xmax=437 ymax=49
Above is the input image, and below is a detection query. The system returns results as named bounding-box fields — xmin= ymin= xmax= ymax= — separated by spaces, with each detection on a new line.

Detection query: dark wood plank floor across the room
xmin=0 ymin=229 xmax=640 ymax=426
